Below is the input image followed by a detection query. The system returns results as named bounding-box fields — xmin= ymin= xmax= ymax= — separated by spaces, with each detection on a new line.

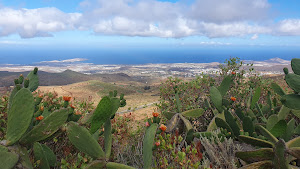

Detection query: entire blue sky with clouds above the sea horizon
xmin=0 ymin=0 xmax=300 ymax=50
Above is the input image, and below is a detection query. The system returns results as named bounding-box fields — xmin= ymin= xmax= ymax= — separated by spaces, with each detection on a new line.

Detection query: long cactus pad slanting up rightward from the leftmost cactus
xmin=20 ymin=109 xmax=69 ymax=144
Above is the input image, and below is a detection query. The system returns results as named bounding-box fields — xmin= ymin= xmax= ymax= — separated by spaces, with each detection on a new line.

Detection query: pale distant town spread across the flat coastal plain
xmin=0 ymin=58 xmax=290 ymax=78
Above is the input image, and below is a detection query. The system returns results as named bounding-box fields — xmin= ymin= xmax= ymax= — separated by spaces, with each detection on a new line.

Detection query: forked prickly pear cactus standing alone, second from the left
xmin=67 ymin=91 xmax=133 ymax=169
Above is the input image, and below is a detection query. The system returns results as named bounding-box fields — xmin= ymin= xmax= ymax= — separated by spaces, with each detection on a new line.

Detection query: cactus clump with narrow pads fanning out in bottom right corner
xmin=236 ymin=125 xmax=300 ymax=169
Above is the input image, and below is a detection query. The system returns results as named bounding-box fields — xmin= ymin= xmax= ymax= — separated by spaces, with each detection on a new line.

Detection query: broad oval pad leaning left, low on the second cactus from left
xmin=67 ymin=122 xmax=105 ymax=159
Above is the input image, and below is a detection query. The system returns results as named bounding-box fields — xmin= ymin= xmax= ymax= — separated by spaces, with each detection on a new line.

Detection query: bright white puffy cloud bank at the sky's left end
xmin=0 ymin=8 xmax=81 ymax=38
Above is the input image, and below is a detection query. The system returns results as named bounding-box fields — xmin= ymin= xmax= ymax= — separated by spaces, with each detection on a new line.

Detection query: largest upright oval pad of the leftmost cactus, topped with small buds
xmin=6 ymin=88 xmax=34 ymax=145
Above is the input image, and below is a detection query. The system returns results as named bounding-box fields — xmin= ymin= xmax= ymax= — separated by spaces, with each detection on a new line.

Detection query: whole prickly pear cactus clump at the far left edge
xmin=0 ymin=68 xmax=70 ymax=169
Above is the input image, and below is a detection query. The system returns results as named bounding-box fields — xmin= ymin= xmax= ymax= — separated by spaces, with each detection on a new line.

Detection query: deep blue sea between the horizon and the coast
xmin=0 ymin=48 xmax=300 ymax=65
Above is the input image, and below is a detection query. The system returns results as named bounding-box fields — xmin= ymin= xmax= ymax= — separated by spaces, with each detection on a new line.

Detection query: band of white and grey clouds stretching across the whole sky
xmin=0 ymin=0 xmax=300 ymax=39
